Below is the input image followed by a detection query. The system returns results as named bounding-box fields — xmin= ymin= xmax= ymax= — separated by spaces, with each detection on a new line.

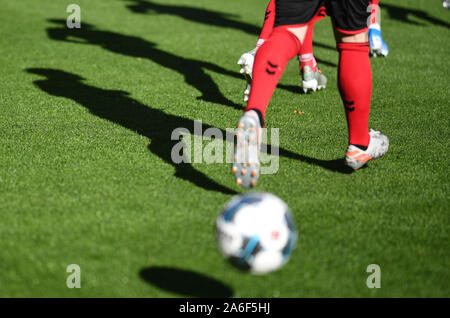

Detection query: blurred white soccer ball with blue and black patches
xmin=216 ymin=192 xmax=297 ymax=274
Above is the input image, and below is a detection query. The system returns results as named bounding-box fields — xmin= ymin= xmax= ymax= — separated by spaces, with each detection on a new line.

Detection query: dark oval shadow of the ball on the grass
xmin=139 ymin=267 xmax=233 ymax=298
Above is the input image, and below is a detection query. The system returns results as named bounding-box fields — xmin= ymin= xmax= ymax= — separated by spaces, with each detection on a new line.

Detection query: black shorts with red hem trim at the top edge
xmin=274 ymin=0 xmax=370 ymax=34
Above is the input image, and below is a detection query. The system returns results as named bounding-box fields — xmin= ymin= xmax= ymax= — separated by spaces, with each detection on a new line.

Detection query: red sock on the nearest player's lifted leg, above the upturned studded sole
xmin=245 ymin=26 xmax=300 ymax=118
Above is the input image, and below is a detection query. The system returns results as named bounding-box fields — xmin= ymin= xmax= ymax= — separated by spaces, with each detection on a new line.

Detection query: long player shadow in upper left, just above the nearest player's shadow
xmin=47 ymin=19 xmax=243 ymax=110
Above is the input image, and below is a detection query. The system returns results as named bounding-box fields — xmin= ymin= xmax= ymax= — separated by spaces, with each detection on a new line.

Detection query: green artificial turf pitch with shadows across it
xmin=0 ymin=0 xmax=450 ymax=297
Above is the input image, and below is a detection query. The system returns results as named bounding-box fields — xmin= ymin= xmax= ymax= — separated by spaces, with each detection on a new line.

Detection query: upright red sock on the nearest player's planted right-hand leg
xmin=338 ymin=43 xmax=372 ymax=146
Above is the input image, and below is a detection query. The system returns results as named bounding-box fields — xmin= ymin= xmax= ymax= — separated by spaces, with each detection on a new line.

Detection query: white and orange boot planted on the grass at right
xmin=345 ymin=129 xmax=389 ymax=170
